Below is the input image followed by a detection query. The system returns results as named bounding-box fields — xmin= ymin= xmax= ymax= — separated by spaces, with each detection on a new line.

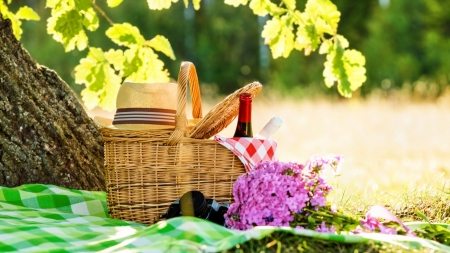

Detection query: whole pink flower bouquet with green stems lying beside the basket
xmin=229 ymin=155 xmax=422 ymax=236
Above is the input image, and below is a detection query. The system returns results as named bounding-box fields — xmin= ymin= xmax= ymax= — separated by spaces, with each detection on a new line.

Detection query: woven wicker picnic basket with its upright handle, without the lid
xmin=100 ymin=63 xmax=255 ymax=225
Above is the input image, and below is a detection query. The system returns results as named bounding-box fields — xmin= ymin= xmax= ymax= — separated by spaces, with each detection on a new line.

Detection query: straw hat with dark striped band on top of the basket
xmin=94 ymin=82 xmax=178 ymax=130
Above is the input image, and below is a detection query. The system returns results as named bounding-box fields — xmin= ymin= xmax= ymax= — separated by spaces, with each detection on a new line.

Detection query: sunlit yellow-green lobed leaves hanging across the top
xmin=5 ymin=0 xmax=366 ymax=110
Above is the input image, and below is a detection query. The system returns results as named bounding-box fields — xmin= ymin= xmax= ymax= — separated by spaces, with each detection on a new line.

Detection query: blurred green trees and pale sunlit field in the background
xmin=6 ymin=0 xmax=450 ymax=213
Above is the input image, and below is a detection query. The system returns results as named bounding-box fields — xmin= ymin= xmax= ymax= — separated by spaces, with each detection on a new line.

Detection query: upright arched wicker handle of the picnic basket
xmin=167 ymin=62 xmax=203 ymax=146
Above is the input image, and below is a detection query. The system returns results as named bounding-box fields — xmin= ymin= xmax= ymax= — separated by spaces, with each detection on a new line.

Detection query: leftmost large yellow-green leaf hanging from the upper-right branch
xmin=262 ymin=16 xmax=295 ymax=59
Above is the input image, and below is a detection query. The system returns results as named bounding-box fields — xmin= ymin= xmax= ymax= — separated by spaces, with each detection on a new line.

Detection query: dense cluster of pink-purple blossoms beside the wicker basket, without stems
xmin=225 ymin=156 xmax=340 ymax=230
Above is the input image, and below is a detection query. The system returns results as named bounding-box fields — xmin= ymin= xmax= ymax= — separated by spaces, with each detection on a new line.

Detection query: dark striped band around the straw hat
xmin=113 ymin=108 xmax=176 ymax=126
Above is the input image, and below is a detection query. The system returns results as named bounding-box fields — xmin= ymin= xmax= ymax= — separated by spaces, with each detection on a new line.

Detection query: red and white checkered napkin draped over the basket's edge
xmin=214 ymin=135 xmax=278 ymax=172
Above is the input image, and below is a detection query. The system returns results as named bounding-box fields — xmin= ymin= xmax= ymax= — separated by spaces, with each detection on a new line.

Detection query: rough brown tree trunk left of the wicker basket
xmin=0 ymin=15 xmax=105 ymax=190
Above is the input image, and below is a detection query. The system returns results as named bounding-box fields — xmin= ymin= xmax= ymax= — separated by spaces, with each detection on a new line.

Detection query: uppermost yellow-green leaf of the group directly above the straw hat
xmin=106 ymin=23 xmax=145 ymax=47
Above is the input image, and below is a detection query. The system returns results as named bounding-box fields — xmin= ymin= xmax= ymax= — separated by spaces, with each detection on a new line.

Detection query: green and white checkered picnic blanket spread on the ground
xmin=0 ymin=184 xmax=450 ymax=252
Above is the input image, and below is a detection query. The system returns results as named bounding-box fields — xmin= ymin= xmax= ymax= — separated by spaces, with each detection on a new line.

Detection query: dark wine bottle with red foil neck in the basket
xmin=234 ymin=93 xmax=253 ymax=137
